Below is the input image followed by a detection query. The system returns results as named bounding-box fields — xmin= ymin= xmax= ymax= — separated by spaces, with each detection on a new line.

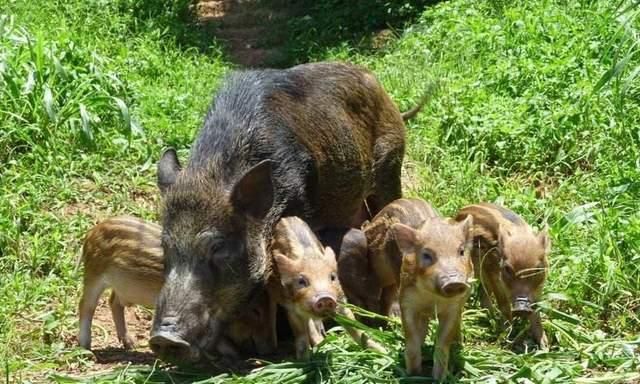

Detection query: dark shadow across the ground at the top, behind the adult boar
xmin=121 ymin=0 xmax=438 ymax=67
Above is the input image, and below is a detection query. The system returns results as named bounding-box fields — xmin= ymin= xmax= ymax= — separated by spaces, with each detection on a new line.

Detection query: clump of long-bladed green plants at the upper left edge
xmin=0 ymin=15 xmax=135 ymax=162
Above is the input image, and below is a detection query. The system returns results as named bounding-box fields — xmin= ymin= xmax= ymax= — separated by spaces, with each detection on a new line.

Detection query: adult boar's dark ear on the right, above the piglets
xmin=231 ymin=160 xmax=273 ymax=219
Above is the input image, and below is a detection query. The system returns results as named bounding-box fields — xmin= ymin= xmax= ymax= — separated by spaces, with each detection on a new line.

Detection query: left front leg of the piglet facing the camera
xmin=402 ymin=305 xmax=429 ymax=376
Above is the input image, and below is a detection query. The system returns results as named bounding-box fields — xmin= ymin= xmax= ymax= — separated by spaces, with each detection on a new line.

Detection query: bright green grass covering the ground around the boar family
xmin=0 ymin=0 xmax=640 ymax=383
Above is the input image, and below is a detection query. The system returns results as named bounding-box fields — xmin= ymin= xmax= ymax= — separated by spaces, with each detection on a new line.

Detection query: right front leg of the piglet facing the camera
xmin=433 ymin=308 xmax=462 ymax=381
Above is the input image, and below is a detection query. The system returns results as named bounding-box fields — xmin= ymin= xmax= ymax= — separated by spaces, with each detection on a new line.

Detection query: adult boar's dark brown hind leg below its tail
xmin=367 ymin=145 xmax=404 ymax=217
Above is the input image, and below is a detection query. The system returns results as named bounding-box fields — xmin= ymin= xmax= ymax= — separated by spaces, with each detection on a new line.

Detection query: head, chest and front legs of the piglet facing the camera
xmin=391 ymin=217 xmax=473 ymax=380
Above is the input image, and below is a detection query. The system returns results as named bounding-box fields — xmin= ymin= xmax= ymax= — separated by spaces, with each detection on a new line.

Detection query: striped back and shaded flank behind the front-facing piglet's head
xmin=362 ymin=199 xmax=438 ymax=316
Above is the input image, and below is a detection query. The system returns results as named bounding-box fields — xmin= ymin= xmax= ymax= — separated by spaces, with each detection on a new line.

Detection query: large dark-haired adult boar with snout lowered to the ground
xmin=150 ymin=63 xmax=405 ymax=360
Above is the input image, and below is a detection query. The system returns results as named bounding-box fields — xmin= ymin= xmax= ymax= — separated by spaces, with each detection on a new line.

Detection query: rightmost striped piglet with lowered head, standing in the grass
xmin=456 ymin=203 xmax=551 ymax=348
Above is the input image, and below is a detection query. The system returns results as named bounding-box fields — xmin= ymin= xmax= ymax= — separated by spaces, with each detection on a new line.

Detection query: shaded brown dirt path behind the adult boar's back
xmin=196 ymin=0 xmax=294 ymax=67
